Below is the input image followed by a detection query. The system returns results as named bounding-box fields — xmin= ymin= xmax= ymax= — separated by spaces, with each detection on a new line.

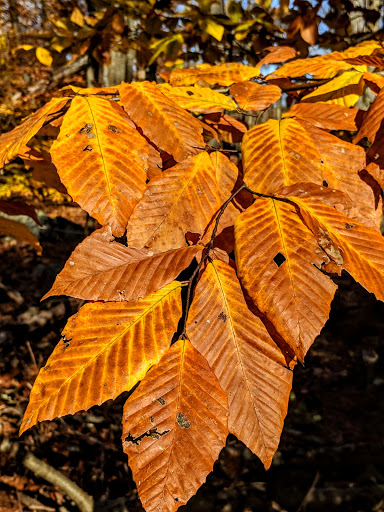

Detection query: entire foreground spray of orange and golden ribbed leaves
xmin=0 ymin=41 xmax=384 ymax=512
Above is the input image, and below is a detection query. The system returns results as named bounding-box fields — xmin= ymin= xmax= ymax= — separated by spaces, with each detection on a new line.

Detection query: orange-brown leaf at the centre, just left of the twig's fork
xmin=127 ymin=152 xmax=237 ymax=251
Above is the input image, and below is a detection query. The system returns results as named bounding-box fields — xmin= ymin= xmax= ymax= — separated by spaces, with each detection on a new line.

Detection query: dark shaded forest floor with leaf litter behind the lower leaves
xmin=0 ymin=207 xmax=384 ymax=512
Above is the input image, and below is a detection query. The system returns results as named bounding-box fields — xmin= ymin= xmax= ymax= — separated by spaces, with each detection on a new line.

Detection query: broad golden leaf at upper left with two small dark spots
xmin=51 ymin=96 xmax=149 ymax=236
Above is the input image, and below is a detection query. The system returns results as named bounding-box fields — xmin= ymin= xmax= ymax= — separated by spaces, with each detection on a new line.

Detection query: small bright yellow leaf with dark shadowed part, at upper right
xmin=302 ymin=71 xmax=364 ymax=107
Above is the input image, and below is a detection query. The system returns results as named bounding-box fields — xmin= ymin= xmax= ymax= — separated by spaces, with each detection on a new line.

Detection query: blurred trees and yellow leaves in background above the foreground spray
xmin=0 ymin=0 xmax=383 ymax=131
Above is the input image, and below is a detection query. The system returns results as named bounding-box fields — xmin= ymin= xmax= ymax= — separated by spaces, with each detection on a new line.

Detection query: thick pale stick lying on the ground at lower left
xmin=23 ymin=453 xmax=93 ymax=512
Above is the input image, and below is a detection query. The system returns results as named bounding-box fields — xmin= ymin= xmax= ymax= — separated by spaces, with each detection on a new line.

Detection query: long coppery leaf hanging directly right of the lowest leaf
xmin=187 ymin=260 xmax=292 ymax=468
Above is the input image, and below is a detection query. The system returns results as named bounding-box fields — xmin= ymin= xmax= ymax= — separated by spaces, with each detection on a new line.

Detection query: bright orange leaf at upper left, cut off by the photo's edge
xmin=0 ymin=98 xmax=68 ymax=168
